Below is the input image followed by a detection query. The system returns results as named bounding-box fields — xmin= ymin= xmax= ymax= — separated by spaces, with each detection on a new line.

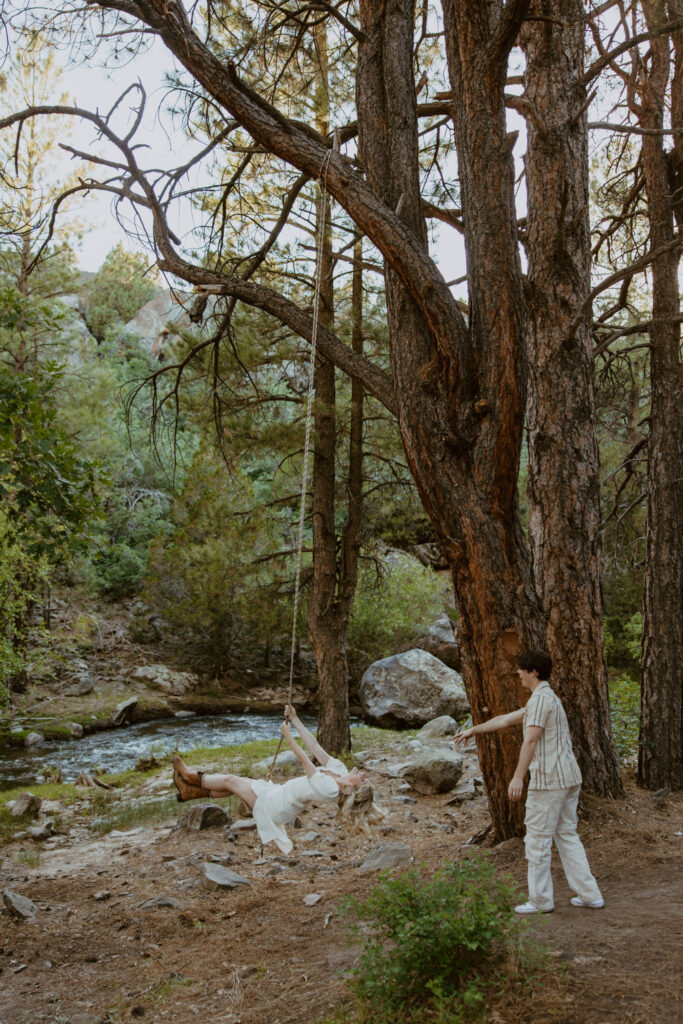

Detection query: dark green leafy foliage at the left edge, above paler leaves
xmin=0 ymin=364 xmax=96 ymax=563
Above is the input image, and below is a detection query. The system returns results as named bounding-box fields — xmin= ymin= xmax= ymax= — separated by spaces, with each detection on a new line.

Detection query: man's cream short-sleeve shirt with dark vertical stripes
xmin=522 ymin=682 xmax=582 ymax=790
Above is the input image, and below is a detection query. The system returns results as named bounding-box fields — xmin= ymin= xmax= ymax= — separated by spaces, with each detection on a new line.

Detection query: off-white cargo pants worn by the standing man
xmin=524 ymin=785 xmax=601 ymax=910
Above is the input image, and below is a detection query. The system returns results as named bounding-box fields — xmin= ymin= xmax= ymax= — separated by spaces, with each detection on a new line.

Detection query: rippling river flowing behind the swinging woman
xmin=0 ymin=713 xmax=316 ymax=790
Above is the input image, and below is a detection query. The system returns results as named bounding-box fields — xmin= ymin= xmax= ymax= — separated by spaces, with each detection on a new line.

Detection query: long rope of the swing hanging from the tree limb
xmin=266 ymin=150 xmax=333 ymax=779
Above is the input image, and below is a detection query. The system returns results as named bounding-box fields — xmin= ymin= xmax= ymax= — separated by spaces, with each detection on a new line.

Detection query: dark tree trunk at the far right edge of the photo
xmin=638 ymin=0 xmax=683 ymax=790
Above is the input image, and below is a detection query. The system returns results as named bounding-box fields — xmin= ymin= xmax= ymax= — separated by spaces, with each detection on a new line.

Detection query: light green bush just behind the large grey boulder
xmin=348 ymin=558 xmax=443 ymax=679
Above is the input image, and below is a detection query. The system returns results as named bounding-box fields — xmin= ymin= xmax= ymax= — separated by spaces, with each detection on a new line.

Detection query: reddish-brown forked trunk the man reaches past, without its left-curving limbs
xmin=356 ymin=0 xmax=543 ymax=839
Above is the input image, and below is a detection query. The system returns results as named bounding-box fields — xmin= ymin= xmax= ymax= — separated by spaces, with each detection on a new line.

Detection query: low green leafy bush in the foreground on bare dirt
xmin=346 ymin=859 xmax=519 ymax=1024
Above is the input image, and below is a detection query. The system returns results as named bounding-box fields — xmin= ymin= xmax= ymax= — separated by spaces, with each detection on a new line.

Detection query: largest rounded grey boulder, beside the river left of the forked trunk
xmin=360 ymin=648 xmax=470 ymax=728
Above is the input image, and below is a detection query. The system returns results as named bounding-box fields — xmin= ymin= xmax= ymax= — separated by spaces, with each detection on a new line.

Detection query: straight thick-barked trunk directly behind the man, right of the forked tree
xmin=520 ymin=0 xmax=622 ymax=797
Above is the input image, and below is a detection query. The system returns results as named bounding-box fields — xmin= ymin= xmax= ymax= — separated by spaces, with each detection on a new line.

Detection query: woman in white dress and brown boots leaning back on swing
xmin=173 ymin=705 xmax=366 ymax=853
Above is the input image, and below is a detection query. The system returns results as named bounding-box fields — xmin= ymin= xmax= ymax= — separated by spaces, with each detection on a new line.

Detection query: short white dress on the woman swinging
xmin=251 ymin=758 xmax=348 ymax=853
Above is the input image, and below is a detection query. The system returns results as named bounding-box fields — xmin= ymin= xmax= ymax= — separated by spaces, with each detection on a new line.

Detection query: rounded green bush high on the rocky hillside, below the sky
xmin=87 ymin=244 xmax=157 ymax=341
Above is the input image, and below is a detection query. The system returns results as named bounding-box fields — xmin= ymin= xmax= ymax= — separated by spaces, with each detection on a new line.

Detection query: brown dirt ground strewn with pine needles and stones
xmin=0 ymin=775 xmax=683 ymax=1024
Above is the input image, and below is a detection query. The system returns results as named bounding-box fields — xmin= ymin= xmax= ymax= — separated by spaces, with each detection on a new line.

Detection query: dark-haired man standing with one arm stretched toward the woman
xmin=454 ymin=650 xmax=605 ymax=913
